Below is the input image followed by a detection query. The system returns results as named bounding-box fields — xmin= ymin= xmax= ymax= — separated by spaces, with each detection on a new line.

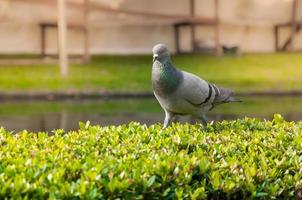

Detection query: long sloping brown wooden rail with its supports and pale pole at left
xmin=6 ymin=0 xmax=224 ymax=76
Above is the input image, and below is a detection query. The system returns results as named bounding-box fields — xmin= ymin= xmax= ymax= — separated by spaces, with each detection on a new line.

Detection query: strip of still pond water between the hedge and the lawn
xmin=0 ymin=97 xmax=302 ymax=132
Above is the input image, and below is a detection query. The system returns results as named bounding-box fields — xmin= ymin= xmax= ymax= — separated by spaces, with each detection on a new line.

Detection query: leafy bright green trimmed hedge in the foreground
xmin=0 ymin=115 xmax=302 ymax=199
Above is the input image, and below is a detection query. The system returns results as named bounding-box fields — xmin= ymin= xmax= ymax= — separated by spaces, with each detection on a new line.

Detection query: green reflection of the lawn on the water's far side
xmin=0 ymin=97 xmax=302 ymax=117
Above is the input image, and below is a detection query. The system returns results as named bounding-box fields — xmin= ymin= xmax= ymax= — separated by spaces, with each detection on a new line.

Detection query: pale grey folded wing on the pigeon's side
xmin=179 ymin=71 xmax=215 ymax=106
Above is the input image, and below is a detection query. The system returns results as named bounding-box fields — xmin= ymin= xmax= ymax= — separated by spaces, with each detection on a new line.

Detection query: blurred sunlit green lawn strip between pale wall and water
xmin=0 ymin=53 xmax=302 ymax=92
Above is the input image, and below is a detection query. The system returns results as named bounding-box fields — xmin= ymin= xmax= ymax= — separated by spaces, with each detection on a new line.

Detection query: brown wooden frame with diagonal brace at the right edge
xmin=274 ymin=0 xmax=302 ymax=52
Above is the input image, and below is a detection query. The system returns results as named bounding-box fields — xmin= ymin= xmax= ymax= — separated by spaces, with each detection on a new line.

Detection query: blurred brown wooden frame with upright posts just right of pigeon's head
xmin=173 ymin=0 xmax=221 ymax=55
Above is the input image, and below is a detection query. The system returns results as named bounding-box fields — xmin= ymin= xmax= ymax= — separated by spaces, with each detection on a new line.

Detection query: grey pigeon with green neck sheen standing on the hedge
xmin=152 ymin=44 xmax=240 ymax=128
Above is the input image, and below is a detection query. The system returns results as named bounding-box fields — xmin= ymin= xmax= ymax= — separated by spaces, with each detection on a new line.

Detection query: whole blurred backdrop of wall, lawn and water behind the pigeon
xmin=0 ymin=0 xmax=302 ymax=131
